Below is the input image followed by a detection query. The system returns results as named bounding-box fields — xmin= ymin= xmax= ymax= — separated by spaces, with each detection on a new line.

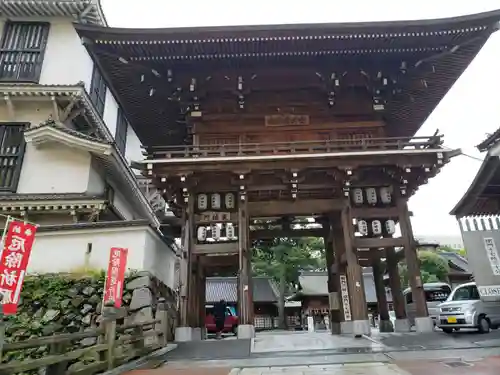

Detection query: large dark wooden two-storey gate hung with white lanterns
xmin=75 ymin=11 xmax=500 ymax=341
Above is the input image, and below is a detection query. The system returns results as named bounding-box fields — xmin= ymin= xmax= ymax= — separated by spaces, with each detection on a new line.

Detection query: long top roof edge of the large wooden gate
xmin=75 ymin=10 xmax=500 ymax=40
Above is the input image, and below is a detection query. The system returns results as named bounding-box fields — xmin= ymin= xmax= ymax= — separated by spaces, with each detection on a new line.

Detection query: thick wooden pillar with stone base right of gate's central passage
xmin=341 ymin=207 xmax=370 ymax=336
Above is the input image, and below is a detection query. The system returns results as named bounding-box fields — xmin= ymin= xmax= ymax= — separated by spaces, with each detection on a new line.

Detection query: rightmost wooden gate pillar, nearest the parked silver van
xmin=397 ymin=196 xmax=429 ymax=318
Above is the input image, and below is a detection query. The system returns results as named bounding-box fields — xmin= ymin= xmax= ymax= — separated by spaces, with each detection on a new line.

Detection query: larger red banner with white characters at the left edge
xmin=0 ymin=220 xmax=36 ymax=315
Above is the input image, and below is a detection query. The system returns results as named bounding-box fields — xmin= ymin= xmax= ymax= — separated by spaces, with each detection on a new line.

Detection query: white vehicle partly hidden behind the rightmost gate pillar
xmin=403 ymin=282 xmax=451 ymax=326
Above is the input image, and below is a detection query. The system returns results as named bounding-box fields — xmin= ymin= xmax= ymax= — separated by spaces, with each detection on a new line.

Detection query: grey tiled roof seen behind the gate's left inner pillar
xmin=205 ymin=277 xmax=278 ymax=303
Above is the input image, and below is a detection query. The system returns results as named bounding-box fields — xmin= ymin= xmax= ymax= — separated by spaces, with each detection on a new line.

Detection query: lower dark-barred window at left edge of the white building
xmin=0 ymin=123 xmax=26 ymax=193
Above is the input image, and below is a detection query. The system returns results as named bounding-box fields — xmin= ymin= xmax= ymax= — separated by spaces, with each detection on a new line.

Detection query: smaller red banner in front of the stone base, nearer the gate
xmin=104 ymin=247 xmax=128 ymax=307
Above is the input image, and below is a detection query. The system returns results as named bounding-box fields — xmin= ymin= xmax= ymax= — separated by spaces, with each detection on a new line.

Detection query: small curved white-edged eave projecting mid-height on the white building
xmin=24 ymin=126 xmax=113 ymax=155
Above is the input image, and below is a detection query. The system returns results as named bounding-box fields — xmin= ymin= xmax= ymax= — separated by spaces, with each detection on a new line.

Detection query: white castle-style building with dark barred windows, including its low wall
xmin=0 ymin=0 xmax=175 ymax=287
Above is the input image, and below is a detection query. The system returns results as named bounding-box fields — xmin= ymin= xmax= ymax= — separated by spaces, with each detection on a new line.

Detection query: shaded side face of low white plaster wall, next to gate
xmin=144 ymin=230 xmax=175 ymax=289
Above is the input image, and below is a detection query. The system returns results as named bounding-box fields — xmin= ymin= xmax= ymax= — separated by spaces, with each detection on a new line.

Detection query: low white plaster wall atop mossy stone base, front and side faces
xmin=28 ymin=227 xmax=175 ymax=288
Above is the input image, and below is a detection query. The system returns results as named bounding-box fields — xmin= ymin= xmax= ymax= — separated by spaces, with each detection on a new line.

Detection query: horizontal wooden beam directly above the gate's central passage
xmin=248 ymin=199 xmax=345 ymax=217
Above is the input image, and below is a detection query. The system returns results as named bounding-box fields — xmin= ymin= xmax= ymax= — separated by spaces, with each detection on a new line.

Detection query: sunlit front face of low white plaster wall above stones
xmin=28 ymin=227 xmax=146 ymax=273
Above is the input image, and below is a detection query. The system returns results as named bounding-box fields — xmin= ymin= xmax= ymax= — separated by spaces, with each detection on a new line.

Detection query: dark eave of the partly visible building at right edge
xmin=450 ymin=155 xmax=500 ymax=217
